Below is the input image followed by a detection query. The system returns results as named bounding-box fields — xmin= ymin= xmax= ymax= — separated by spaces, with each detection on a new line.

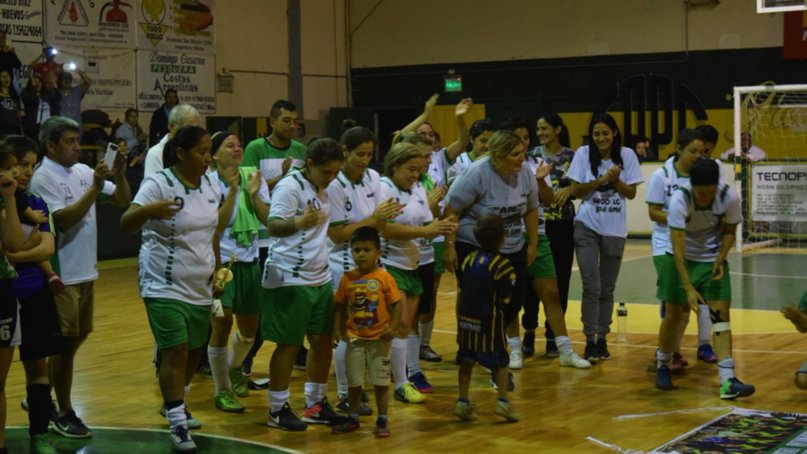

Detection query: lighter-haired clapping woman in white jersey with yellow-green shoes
xmin=381 ymin=142 xmax=455 ymax=403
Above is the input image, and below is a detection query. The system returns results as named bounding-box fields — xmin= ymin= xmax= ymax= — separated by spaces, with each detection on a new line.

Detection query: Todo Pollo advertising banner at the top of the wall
xmin=137 ymin=0 xmax=216 ymax=54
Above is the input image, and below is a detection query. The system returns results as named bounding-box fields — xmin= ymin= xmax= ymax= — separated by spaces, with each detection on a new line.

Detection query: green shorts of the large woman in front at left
xmin=144 ymin=298 xmax=210 ymax=350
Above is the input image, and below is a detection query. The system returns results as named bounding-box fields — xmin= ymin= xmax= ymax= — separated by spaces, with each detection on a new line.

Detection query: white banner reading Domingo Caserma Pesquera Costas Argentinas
xmin=137 ymin=51 xmax=216 ymax=113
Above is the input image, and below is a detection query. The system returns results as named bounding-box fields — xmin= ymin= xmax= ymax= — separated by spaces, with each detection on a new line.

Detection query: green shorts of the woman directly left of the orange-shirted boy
xmin=261 ymin=282 xmax=334 ymax=345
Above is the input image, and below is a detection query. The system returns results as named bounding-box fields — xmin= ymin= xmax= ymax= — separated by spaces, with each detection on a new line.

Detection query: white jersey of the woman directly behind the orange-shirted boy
xmin=328 ymin=168 xmax=382 ymax=288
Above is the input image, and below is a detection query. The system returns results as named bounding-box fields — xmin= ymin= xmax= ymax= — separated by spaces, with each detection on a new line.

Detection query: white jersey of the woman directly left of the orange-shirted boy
xmin=263 ymin=169 xmax=331 ymax=288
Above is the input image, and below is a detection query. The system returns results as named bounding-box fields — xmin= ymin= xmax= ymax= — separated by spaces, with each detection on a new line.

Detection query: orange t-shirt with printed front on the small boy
xmin=335 ymin=268 xmax=401 ymax=340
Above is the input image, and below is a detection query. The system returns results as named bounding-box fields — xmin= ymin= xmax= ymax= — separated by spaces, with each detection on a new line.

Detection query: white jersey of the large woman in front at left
xmin=132 ymin=168 xmax=221 ymax=306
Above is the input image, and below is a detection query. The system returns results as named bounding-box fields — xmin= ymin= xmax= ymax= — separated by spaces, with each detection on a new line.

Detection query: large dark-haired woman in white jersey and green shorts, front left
xmin=120 ymin=126 xmax=226 ymax=452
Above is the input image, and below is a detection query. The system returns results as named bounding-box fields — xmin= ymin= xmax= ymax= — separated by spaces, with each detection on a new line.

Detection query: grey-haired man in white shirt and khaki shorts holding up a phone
xmin=30 ymin=117 xmax=132 ymax=438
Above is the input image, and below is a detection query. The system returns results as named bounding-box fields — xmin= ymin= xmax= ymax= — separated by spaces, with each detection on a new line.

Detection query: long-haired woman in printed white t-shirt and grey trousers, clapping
xmin=567 ymin=113 xmax=643 ymax=361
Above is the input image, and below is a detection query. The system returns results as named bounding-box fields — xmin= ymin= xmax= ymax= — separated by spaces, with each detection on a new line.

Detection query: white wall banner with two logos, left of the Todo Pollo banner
xmin=45 ymin=0 xmax=137 ymax=49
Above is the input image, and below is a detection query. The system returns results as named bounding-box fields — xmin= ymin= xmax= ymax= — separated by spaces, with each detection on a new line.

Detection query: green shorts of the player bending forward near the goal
xmin=653 ymin=255 xmax=731 ymax=305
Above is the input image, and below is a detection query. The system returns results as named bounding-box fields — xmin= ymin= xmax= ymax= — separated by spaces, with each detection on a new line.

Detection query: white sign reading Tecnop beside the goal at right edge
xmin=750 ymin=164 xmax=807 ymax=223
